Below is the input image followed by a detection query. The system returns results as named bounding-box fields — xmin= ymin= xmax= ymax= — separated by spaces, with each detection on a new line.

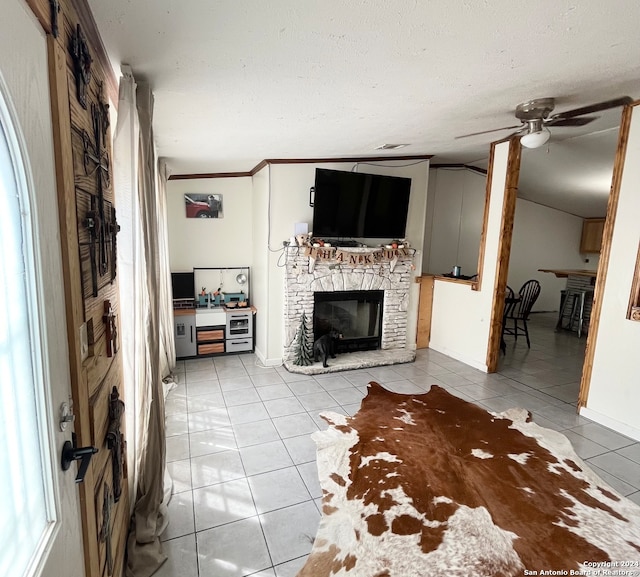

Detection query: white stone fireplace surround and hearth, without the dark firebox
xmin=283 ymin=247 xmax=415 ymax=374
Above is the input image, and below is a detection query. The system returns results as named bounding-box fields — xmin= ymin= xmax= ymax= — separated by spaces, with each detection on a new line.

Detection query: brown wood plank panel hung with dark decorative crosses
xmin=29 ymin=0 xmax=130 ymax=577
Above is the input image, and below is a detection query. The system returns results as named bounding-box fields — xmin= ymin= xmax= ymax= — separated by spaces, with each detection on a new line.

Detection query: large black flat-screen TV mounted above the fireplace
xmin=312 ymin=168 xmax=411 ymax=240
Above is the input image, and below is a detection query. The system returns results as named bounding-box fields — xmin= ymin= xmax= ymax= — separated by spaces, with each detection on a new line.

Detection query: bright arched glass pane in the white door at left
xmin=0 ymin=92 xmax=55 ymax=575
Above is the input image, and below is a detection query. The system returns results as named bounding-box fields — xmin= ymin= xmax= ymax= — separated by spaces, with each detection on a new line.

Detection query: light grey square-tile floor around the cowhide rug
xmin=157 ymin=314 xmax=640 ymax=577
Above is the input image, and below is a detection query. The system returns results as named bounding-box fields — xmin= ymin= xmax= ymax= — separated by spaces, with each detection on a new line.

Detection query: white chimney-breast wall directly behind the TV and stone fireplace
xmin=266 ymin=161 xmax=429 ymax=359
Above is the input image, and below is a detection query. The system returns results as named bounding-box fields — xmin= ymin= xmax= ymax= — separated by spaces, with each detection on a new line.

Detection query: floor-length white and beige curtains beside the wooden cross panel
xmin=114 ymin=71 xmax=175 ymax=577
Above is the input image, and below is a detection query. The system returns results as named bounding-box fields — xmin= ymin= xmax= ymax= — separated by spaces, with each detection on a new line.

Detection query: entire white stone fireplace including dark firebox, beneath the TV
xmin=283 ymin=247 xmax=415 ymax=374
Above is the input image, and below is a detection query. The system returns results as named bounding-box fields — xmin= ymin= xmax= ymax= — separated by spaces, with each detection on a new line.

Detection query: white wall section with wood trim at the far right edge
xmin=581 ymin=107 xmax=640 ymax=441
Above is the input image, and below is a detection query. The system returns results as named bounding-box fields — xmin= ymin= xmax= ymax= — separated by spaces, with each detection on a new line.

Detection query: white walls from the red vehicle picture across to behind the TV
xmin=167 ymin=161 xmax=429 ymax=365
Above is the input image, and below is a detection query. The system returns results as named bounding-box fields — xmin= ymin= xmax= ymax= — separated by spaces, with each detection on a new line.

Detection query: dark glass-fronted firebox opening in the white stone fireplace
xmin=313 ymin=290 xmax=384 ymax=353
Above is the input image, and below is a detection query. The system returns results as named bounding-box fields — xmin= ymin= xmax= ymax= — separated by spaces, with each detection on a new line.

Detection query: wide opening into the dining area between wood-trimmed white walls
xmin=495 ymin=108 xmax=620 ymax=404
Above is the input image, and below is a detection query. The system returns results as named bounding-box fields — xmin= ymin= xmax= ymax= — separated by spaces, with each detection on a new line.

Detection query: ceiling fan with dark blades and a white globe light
xmin=456 ymin=96 xmax=633 ymax=148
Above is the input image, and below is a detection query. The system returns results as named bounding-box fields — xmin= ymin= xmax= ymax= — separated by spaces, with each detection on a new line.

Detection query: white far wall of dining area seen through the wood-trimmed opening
xmin=507 ymin=198 xmax=597 ymax=311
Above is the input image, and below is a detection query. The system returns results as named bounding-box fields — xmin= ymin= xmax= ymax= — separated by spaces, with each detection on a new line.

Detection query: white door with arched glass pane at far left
xmin=0 ymin=0 xmax=84 ymax=577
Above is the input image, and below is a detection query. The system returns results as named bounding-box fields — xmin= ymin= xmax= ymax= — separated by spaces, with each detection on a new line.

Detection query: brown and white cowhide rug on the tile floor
xmin=298 ymin=382 xmax=640 ymax=577
